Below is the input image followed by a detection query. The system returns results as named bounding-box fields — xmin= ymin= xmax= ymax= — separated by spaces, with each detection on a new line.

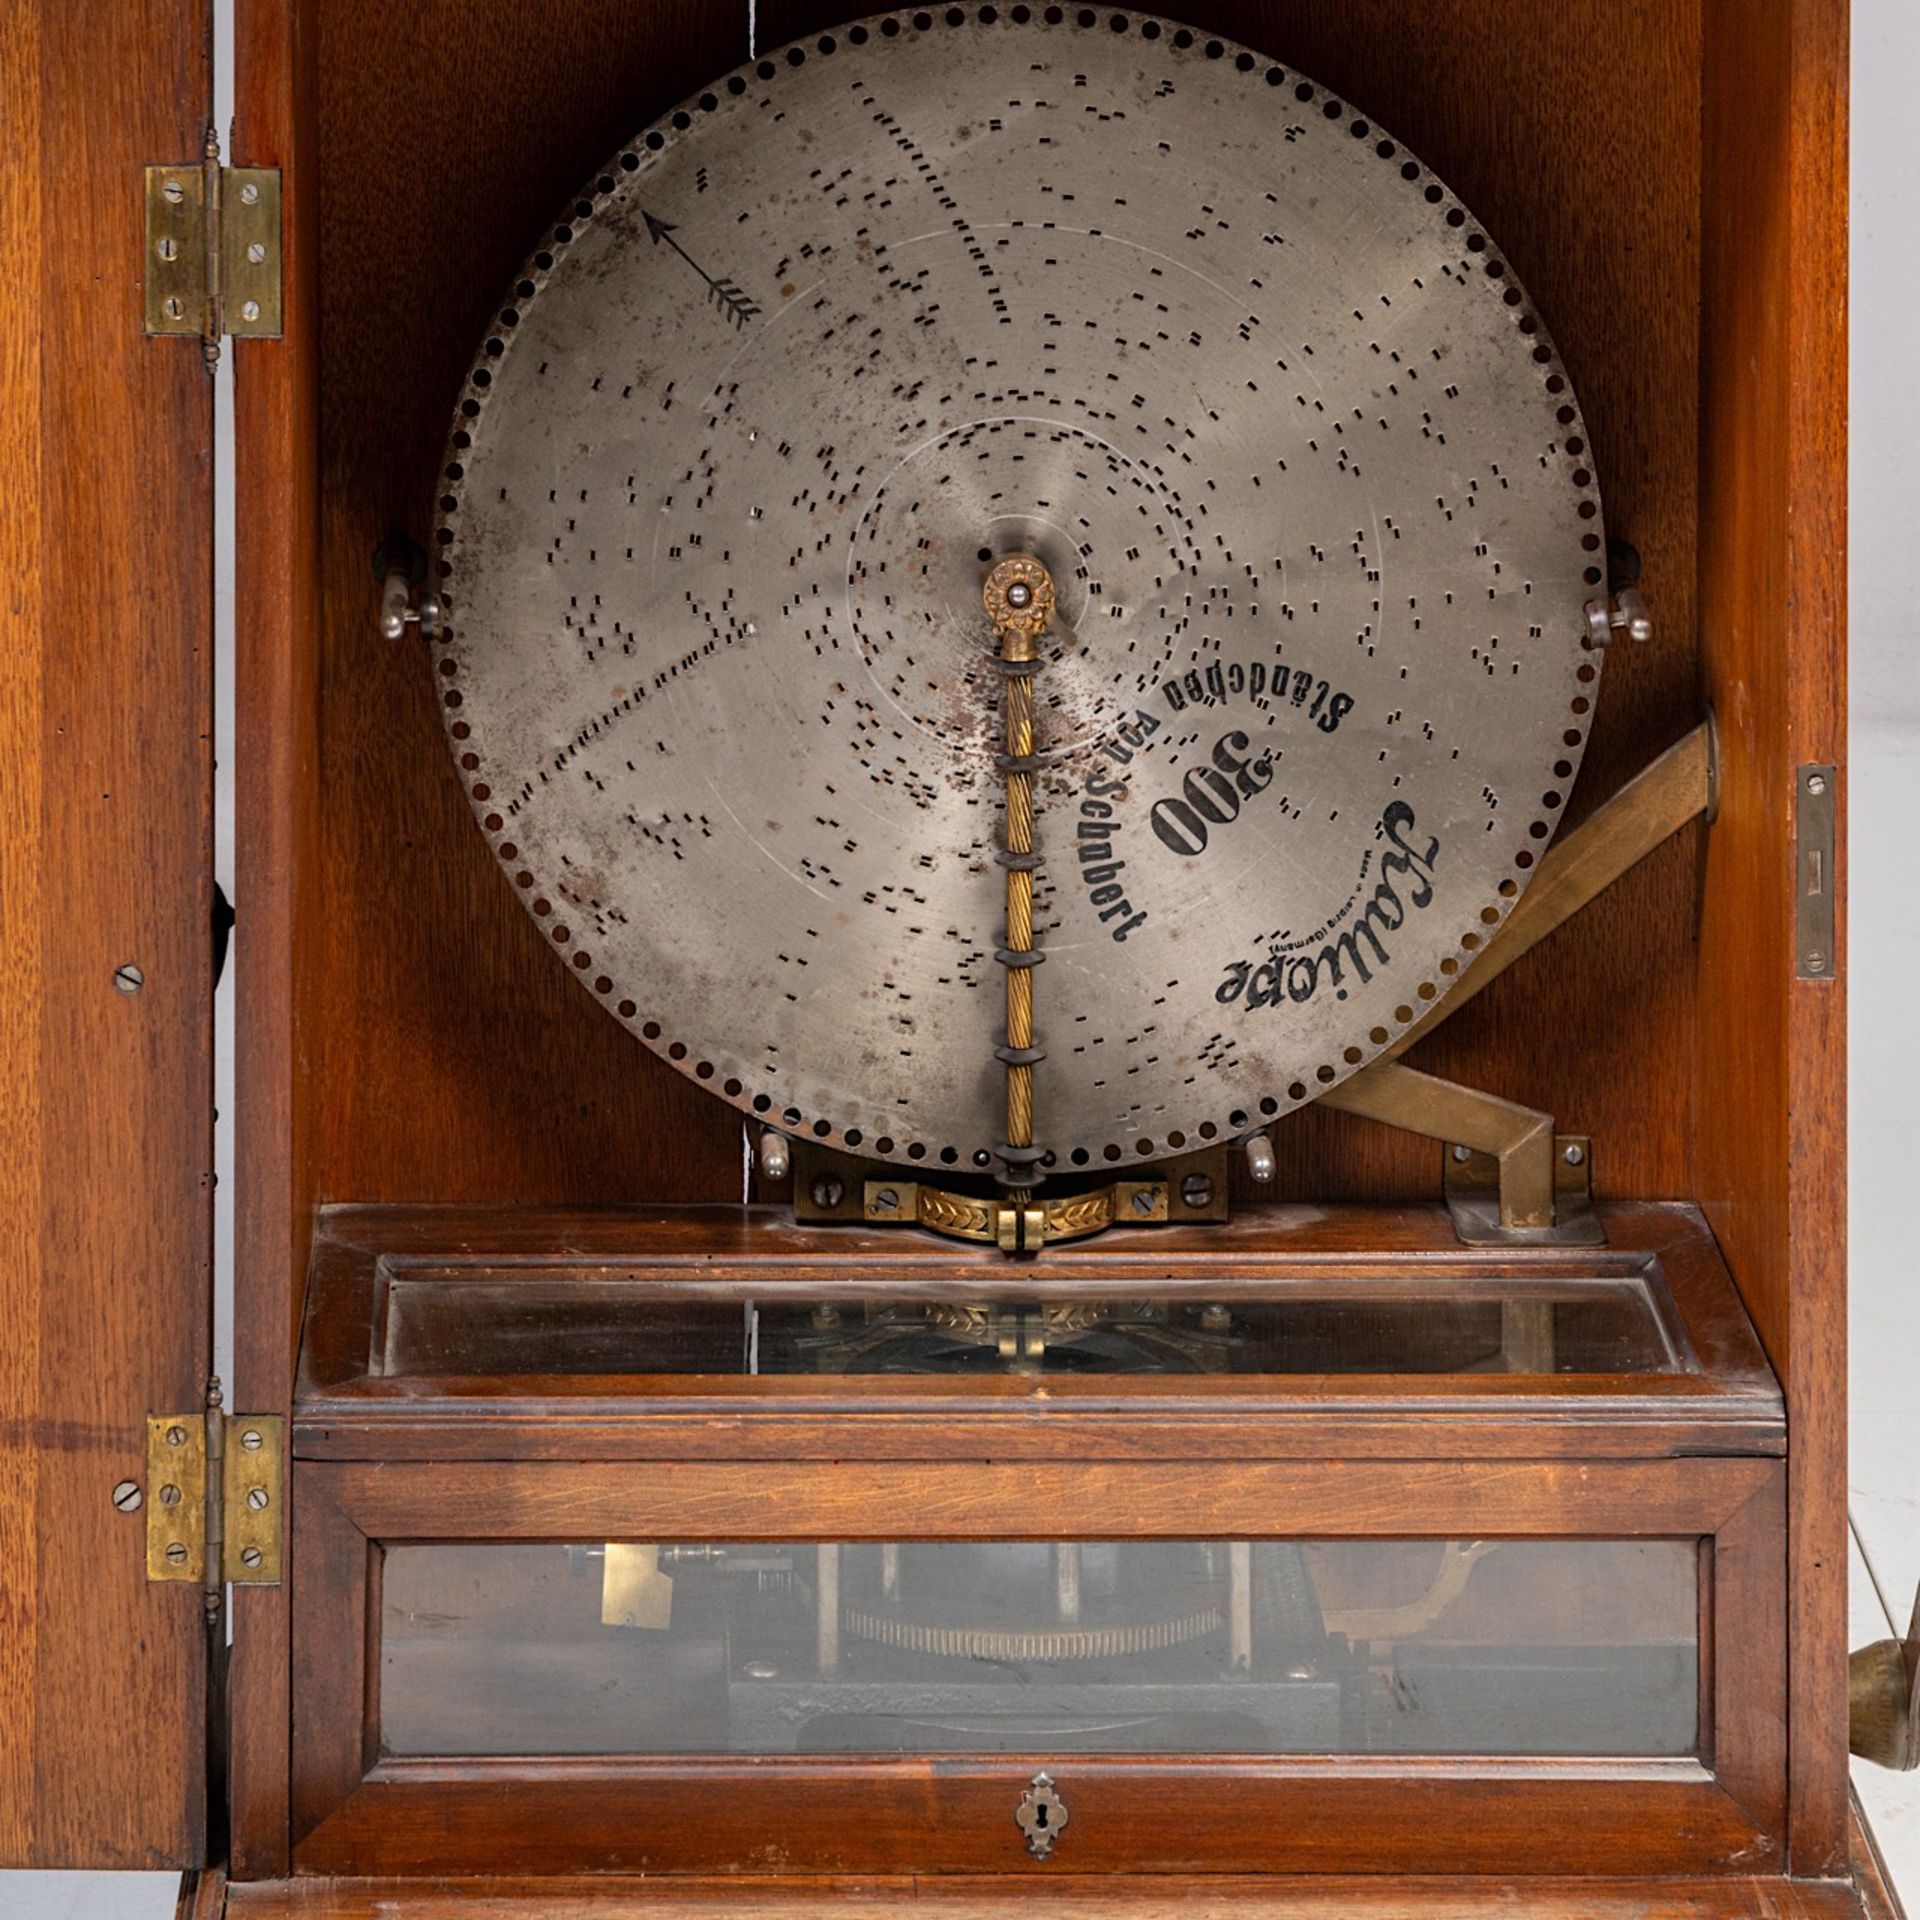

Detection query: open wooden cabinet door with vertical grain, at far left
xmin=0 ymin=0 xmax=213 ymax=1868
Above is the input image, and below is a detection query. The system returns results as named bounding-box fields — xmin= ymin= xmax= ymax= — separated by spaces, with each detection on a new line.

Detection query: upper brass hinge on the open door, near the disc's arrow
xmin=146 ymin=131 xmax=280 ymax=361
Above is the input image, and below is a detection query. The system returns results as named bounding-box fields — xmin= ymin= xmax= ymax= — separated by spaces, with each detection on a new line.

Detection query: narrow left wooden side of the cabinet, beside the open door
xmin=227 ymin=0 xmax=324 ymax=1876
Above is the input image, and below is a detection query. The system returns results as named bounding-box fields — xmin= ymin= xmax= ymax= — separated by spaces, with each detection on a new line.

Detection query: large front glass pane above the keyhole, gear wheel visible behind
xmin=378 ymin=1540 xmax=1697 ymax=1757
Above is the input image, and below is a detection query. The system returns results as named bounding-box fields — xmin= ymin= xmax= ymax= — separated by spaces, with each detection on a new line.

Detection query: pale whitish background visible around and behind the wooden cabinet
xmin=0 ymin=0 xmax=1920 ymax=1920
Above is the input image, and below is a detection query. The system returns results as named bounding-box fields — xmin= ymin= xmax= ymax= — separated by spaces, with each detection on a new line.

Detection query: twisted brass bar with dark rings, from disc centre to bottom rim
xmin=981 ymin=553 xmax=1054 ymax=1190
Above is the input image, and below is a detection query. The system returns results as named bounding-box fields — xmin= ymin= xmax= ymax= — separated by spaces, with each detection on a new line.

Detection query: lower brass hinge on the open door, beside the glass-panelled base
xmin=146 ymin=1380 xmax=286 ymax=1617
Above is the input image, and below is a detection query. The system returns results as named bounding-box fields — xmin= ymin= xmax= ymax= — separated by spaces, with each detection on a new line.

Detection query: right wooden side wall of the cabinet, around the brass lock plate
xmin=1693 ymin=0 xmax=1847 ymax=1874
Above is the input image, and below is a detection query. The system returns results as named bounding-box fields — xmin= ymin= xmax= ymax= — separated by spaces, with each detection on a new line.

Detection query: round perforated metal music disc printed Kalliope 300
xmin=434 ymin=8 xmax=1601 ymax=1169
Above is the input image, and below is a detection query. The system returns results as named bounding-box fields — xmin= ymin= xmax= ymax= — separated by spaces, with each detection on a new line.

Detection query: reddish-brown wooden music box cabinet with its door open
xmin=0 ymin=0 xmax=1872 ymax=1916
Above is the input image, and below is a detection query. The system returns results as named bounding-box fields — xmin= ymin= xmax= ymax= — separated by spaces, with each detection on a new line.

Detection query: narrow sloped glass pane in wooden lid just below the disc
xmin=372 ymin=1267 xmax=1692 ymax=1377
